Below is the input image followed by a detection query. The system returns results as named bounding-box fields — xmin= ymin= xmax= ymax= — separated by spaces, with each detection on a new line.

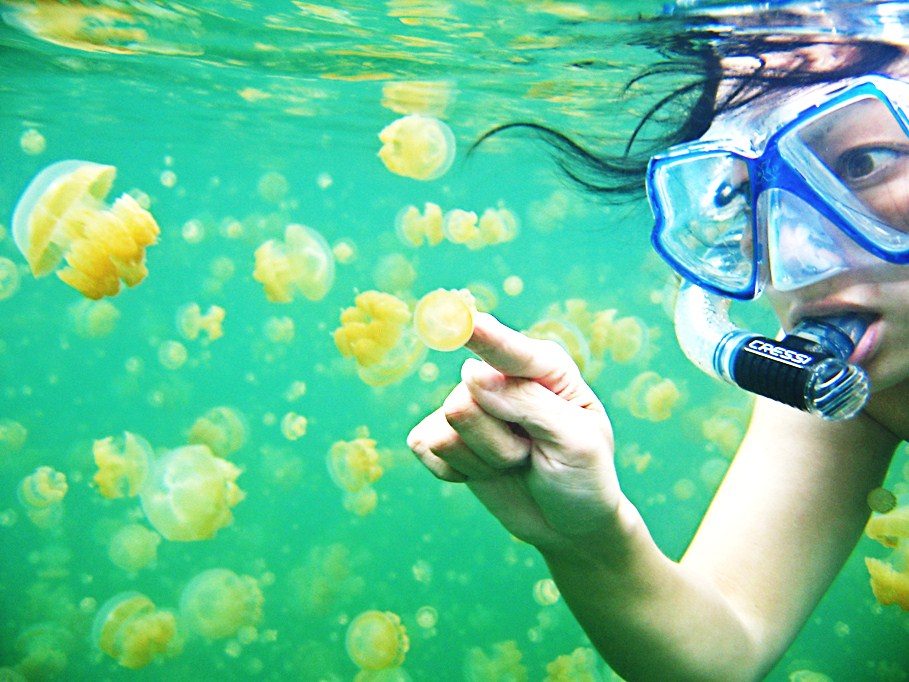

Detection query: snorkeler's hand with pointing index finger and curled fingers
xmin=407 ymin=314 xmax=622 ymax=552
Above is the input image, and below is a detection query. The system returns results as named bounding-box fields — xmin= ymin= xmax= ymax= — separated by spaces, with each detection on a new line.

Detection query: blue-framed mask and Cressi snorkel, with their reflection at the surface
xmin=647 ymin=0 xmax=909 ymax=419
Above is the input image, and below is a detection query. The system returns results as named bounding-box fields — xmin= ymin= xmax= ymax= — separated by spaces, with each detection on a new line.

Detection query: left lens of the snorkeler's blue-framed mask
xmin=651 ymin=152 xmax=755 ymax=297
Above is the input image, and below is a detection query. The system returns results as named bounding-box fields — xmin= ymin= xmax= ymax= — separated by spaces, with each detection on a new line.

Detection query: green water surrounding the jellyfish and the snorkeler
xmin=0 ymin=0 xmax=909 ymax=681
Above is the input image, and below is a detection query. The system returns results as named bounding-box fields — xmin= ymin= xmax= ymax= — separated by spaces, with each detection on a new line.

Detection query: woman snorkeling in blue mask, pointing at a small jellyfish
xmin=408 ymin=0 xmax=909 ymax=682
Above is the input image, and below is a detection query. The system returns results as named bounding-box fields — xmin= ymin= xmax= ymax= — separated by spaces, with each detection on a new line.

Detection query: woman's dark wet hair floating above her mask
xmin=468 ymin=18 xmax=905 ymax=203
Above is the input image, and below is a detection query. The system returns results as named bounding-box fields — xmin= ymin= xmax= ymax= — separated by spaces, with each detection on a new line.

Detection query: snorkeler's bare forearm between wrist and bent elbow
xmin=543 ymin=494 xmax=775 ymax=682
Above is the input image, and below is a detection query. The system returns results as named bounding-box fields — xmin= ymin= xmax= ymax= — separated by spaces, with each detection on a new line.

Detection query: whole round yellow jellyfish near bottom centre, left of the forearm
xmin=345 ymin=610 xmax=410 ymax=670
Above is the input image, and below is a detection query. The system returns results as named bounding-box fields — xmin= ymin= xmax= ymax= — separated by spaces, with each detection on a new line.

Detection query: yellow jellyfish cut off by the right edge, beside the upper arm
xmin=865 ymin=505 xmax=909 ymax=611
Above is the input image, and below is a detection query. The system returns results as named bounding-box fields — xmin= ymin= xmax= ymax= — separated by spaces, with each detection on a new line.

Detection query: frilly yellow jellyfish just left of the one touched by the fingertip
xmin=333 ymin=291 xmax=426 ymax=386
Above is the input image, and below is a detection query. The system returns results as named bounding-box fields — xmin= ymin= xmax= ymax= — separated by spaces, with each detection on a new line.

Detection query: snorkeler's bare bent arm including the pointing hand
xmin=408 ymin=315 xmax=899 ymax=681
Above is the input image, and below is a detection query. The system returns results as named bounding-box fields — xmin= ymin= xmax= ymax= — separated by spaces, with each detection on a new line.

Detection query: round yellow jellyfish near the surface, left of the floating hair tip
xmin=379 ymin=114 xmax=456 ymax=180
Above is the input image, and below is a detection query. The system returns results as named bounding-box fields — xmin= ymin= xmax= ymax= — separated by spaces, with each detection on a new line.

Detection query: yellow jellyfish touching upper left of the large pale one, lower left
xmin=92 ymin=431 xmax=155 ymax=499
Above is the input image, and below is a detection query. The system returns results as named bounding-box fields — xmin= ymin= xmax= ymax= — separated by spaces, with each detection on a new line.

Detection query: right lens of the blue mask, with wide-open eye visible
xmin=792 ymin=96 xmax=909 ymax=254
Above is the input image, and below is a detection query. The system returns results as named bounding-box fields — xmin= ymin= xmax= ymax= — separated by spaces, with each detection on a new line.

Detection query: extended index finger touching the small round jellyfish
xmin=466 ymin=313 xmax=568 ymax=379
